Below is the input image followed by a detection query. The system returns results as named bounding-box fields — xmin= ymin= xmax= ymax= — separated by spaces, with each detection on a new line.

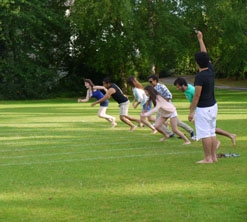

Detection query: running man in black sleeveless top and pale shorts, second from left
xmin=92 ymin=78 xmax=142 ymax=131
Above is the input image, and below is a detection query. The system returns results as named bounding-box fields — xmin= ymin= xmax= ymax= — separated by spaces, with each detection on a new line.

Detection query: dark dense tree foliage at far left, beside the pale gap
xmin=0 ymin=0 xmax=70 ymax=99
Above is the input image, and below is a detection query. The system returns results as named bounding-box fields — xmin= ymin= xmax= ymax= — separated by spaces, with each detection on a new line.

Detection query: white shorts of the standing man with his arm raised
xmin=195 ymin=103 xmax=218 ymax=140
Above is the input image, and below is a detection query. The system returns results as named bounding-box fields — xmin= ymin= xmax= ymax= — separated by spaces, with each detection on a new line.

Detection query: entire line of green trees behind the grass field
xmin=0 ymin=0 xmax=247 ymax=99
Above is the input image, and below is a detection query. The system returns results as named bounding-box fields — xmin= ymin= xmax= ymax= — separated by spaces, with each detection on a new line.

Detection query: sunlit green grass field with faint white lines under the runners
xmin=0 ymin=87 xmax=247 ymax=222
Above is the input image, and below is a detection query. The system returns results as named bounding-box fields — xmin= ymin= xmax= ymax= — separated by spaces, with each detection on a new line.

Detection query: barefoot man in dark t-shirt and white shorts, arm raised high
xmin=188 ymin=31 xmax=218 ymax=163
